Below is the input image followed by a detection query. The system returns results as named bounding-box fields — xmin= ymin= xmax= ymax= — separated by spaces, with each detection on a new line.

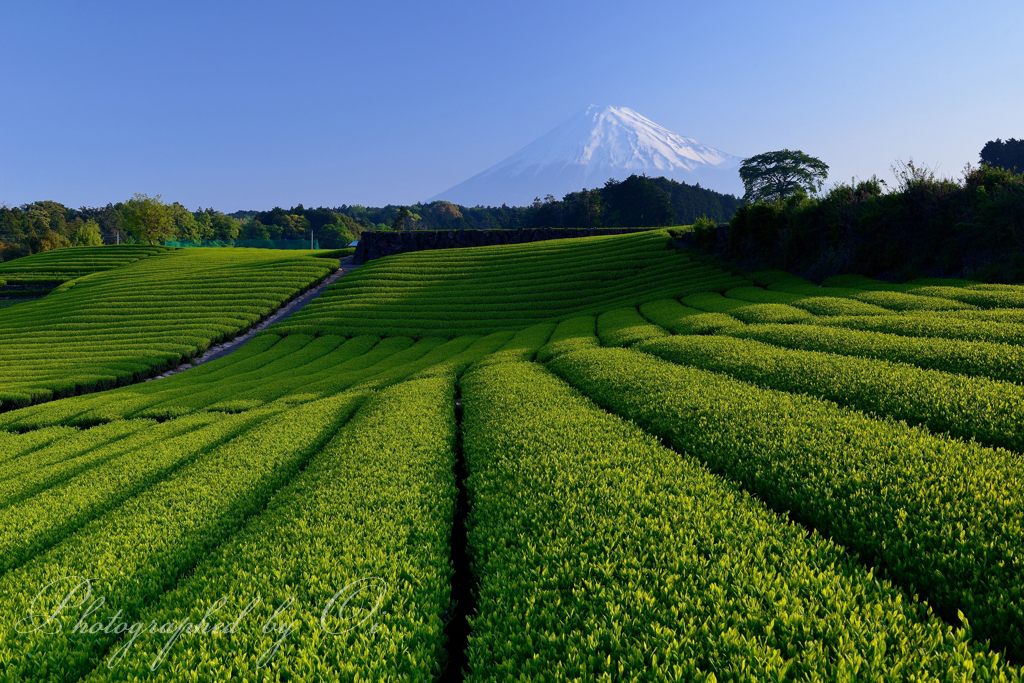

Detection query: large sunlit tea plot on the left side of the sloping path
xmin=0 ymin=249 xmax=337 ymax=410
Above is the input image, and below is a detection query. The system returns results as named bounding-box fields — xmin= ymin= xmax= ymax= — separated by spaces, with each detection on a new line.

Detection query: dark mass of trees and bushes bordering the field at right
xmin=716 ymin=138 xmax=1024 ymax=282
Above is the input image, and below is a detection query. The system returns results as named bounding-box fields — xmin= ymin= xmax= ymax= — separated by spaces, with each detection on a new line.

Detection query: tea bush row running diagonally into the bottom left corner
xmin=0 ymin=395 xmax=362 ymax=683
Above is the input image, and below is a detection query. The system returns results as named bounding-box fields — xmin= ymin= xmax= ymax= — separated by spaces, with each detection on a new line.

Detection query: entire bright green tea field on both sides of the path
xmin=0 ymin=230 xmax=1024 ymax=683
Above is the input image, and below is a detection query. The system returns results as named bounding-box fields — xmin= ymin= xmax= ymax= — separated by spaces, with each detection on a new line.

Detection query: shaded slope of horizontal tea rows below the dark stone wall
xmin=279 ymin=230 xmax=748 ymax=337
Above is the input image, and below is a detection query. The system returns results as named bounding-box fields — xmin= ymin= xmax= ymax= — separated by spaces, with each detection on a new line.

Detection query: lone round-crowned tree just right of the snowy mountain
xmin=739 ymin=150 xmax=828 ymax=204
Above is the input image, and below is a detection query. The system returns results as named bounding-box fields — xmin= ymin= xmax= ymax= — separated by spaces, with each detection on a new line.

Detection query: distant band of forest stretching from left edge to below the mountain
xmin=0 ymin=175 xmax=740 ymax=260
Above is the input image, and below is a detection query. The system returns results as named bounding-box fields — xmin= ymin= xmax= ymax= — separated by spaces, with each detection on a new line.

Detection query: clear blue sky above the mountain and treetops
xmin=0 ymin=0 xmax=1024 ymax=212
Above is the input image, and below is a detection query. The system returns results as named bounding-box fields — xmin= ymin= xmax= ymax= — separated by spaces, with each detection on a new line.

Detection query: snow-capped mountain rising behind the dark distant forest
xmin=430 ymin=104 xmax=743 ymax=206
